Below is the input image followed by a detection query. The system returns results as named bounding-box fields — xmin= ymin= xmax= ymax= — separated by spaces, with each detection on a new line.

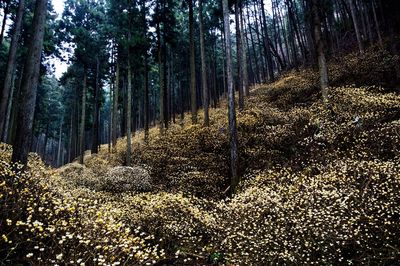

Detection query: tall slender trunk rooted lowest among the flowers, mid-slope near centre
xmin=222 ymin=0 xmax=239 ymax=194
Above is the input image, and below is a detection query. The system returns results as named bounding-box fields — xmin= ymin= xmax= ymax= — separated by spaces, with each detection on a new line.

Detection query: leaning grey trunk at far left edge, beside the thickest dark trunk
xmin=0 ymin=0 xmax=25 ymax=142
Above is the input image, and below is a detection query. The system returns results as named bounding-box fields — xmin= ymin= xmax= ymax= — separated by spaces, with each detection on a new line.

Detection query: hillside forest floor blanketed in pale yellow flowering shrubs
xmin=0 ymin=49 xmax=400 ymax=265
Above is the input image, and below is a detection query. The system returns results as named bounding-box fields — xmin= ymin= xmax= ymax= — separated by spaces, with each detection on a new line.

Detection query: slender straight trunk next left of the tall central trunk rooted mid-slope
xmin=199 ymin=0 xmax=210 ymax=127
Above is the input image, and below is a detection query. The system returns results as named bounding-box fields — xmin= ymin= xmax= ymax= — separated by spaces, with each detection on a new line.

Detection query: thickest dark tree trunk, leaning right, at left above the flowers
xmin=12 ymin=0 xmax=47 ymax=166
